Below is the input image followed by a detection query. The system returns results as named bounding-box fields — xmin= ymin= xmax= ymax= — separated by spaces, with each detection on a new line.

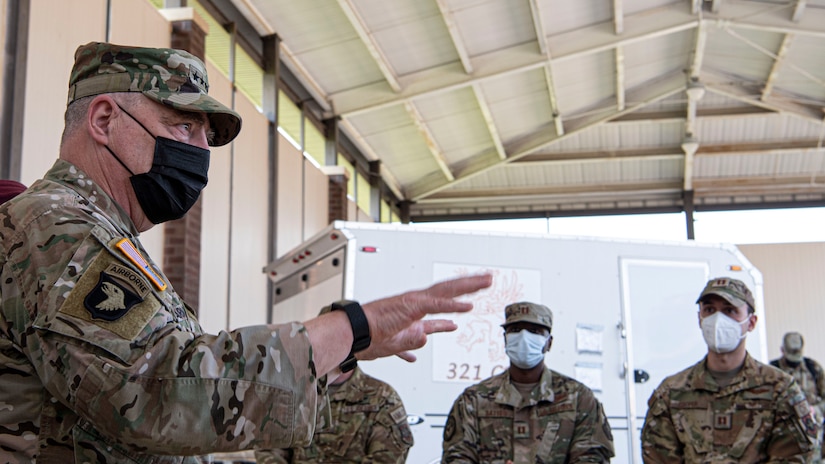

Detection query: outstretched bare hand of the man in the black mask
xmin=357 ymin=274 xmax=493 ymax=361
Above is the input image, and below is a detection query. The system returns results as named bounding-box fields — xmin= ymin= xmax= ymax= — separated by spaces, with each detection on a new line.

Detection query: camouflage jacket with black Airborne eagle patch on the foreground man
xmin=0 ymin=160 xmax=317 ymax=464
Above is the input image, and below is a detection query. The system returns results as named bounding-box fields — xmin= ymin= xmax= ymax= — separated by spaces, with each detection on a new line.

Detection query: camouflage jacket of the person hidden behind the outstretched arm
xmin=255 ymin=367 xmax=413 ymax=464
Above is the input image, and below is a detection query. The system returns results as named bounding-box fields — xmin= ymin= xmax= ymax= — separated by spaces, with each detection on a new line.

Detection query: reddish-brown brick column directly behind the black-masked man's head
xmin=163 ymin=8 xmax=206 ymax=314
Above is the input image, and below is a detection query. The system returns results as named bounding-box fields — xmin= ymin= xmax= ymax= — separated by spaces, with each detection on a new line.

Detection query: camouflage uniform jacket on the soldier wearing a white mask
xmin=642 ymin=354 xmax=817 ymax=463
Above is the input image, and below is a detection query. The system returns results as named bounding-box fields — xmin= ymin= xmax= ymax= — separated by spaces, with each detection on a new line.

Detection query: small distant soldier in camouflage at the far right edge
xmin=770 ymin=332 xmax=825 ymax=463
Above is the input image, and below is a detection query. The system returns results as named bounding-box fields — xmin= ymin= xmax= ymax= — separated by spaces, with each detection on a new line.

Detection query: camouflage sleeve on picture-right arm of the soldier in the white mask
xmin=766 ymin=376 xmax=820 ymax=463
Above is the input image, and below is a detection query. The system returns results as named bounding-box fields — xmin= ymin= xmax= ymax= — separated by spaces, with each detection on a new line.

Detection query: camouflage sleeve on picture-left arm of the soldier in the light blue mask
xmin=441 ymin=393 xmax=479 ymax=464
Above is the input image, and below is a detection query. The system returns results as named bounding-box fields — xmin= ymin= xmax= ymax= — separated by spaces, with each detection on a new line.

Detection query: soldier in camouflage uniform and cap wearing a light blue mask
xmin=441 ymin=302 xmax=614 ymax=464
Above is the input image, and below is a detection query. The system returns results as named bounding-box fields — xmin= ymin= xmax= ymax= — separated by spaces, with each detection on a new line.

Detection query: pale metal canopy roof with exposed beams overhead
xmin=213 ymin=0 xmax=825 ymax=222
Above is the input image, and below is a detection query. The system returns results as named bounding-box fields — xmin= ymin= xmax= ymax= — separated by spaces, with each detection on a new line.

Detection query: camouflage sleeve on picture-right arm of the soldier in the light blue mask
xmin=567 ymin=390 xmax=615 ymax=463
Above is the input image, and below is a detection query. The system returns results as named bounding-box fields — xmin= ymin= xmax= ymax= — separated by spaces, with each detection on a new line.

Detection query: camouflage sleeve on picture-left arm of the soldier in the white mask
xmin=642 ymin=386 xmax=685 ymax=464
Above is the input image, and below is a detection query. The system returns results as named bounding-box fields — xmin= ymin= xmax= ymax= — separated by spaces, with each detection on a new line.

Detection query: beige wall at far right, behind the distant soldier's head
xmin=738 ymin=243 xmax=825 ymax=370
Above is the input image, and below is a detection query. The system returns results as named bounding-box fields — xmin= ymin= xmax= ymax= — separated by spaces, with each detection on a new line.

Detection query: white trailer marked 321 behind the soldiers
xmin=264 ymin=222 xmax=767 ymax=464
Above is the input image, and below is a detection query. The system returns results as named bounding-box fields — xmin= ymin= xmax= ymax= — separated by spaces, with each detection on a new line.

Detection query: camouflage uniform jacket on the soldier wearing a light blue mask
xmin=441 ymin=369 xmax=614 ymax=464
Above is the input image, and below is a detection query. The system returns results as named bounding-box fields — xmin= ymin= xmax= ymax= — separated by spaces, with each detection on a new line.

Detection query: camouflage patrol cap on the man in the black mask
xmin=67 ymin=42 xmax=241 ymax=147
